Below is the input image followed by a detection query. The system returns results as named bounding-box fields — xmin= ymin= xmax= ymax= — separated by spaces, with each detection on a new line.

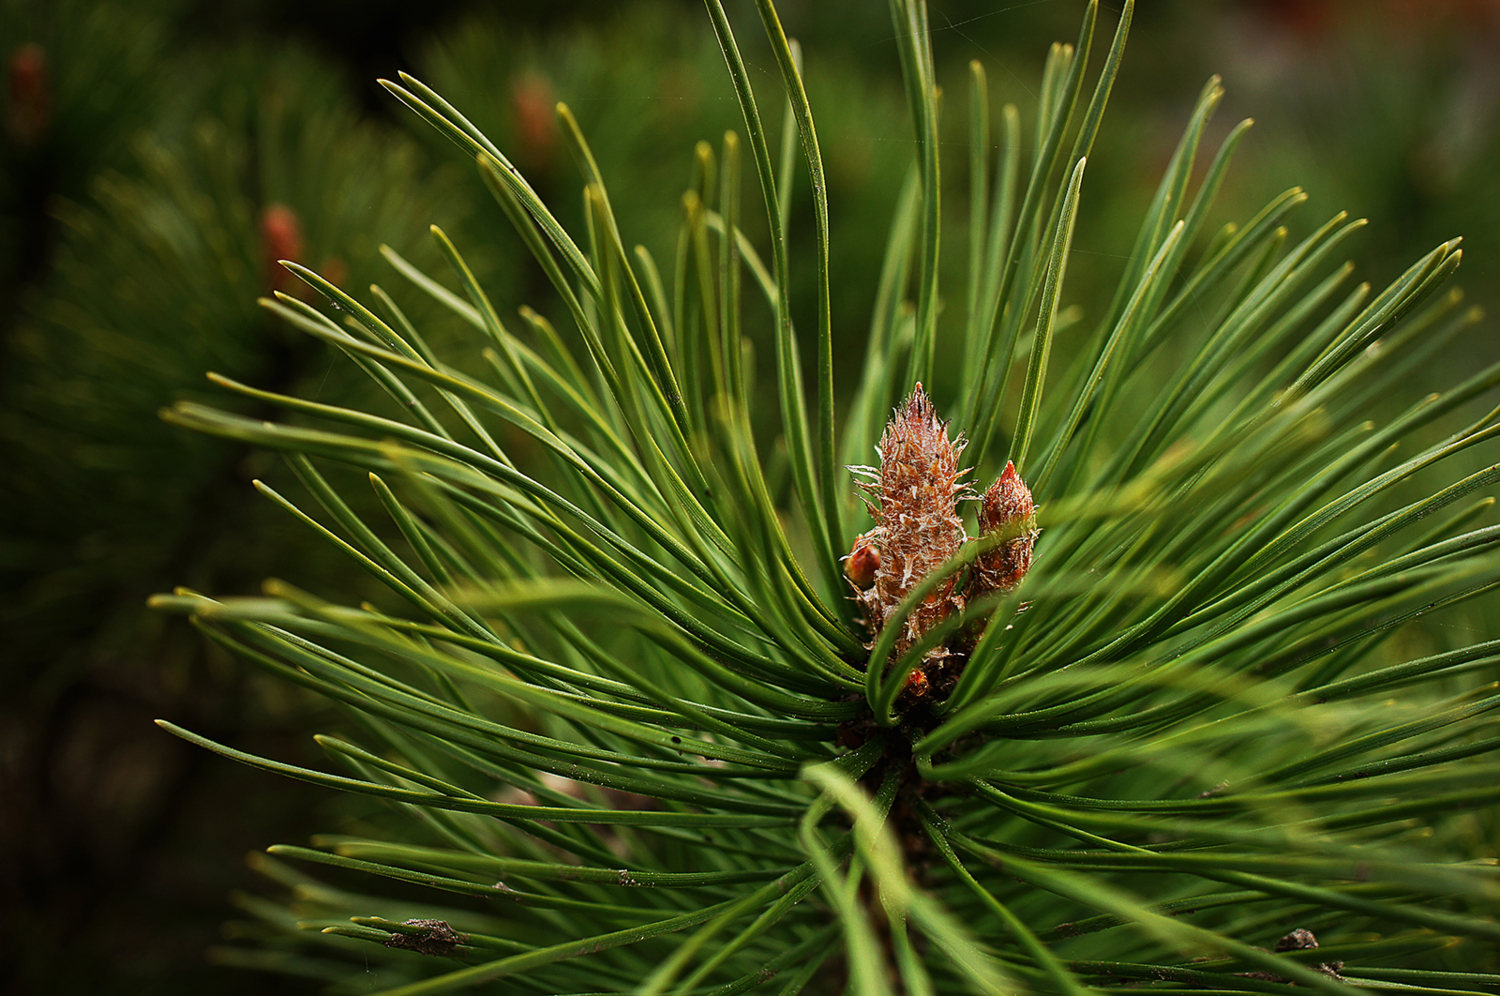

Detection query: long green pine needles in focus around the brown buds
xmin=155 ymin=0 xmax=1500 ymax=996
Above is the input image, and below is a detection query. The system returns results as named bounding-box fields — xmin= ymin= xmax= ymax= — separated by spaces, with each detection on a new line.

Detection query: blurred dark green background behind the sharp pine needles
xmin=0 ymin=0 xmax=1500 ymax=996
